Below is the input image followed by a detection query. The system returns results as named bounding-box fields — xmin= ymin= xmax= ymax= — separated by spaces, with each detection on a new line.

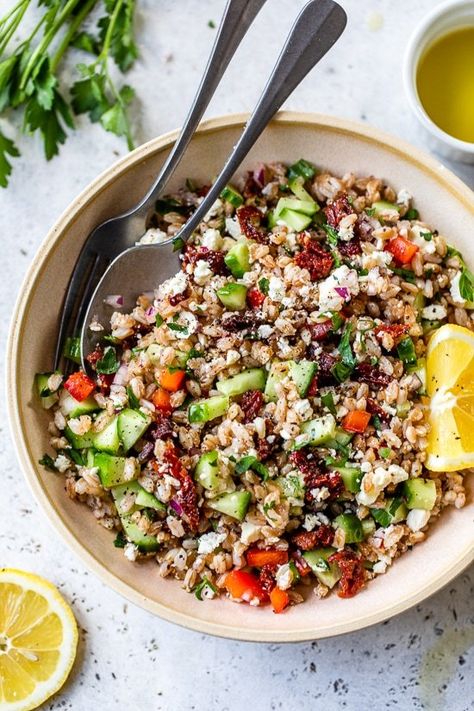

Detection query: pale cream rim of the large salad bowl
xmin=6 ymin=111 xmax=474 ymax=643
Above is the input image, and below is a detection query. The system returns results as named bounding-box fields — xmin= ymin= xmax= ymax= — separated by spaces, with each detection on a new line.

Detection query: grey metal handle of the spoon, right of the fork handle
xmin=174 ymin=0 xmax=347 ymax=244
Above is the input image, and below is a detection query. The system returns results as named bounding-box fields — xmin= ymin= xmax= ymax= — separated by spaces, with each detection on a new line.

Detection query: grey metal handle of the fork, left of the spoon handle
xmin=140 ymin=0 xmax=266 ymax=209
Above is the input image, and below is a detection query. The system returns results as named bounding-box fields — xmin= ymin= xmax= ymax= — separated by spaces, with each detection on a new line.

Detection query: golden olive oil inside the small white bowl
xmin=416 ymin=26 xmax=474 ymax=143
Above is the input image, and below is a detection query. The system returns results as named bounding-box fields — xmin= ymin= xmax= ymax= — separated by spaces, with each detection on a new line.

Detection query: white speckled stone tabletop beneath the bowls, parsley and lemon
xmin=0 ymin=0 xmax=474 ymax=711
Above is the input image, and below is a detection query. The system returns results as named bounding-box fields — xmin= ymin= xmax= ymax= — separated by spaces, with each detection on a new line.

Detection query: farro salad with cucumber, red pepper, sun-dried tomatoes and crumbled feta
xmin=36 ymin=159 xmax=474 ymax=612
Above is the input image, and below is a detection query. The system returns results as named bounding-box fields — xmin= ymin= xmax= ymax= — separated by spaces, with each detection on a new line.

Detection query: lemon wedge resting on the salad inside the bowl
xmin=426 ymin=324 xmax=474 ymax=472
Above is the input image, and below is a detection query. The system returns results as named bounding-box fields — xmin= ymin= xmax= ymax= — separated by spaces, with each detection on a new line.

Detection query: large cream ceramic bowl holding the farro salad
xmin=7 ymin=113 xmax=474 ymax=642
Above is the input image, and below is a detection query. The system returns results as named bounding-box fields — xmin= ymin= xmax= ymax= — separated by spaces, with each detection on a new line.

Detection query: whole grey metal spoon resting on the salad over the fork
xmin=81 ymin=0 xmax=347 ymax=371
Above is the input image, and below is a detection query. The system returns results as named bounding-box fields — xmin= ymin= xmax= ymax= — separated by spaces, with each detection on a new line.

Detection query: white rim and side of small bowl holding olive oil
xmin=403 ymin=0 xmax=474 ymax=156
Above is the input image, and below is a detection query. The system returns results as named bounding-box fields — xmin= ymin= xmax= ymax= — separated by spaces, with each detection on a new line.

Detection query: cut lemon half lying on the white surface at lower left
xmin=0 ymin=568 xmax=77 ymax=711
